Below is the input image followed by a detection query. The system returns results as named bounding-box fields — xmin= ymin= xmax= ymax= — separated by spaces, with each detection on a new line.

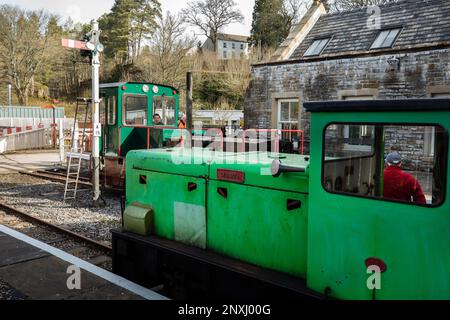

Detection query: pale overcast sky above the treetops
xmin=0 ymin=0 xmax=255 ymax=35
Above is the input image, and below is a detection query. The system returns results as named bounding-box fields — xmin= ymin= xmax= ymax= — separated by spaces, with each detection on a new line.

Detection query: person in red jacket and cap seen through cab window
xmin=383 ymin=152 xmax=427 ymax=204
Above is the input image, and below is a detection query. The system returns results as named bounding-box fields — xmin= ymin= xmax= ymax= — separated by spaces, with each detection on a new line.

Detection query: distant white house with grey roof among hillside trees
xmin=202 ymin=33 xmax=249 ymax=60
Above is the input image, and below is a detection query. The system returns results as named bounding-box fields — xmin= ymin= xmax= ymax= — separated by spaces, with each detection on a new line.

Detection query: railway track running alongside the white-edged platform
xmin=0 ymin=199 xmax=111 ymax=254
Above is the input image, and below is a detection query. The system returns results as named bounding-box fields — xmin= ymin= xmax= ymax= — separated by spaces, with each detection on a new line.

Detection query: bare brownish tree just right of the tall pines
xmin=150 ymin=12 xmax=195 ymax=84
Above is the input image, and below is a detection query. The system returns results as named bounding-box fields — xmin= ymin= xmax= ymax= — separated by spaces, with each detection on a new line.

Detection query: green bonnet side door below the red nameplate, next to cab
xmin=207 ymin=178 xmax=308 ymax=278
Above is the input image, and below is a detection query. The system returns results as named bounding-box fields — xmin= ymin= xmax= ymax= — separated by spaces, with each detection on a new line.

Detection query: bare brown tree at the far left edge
xmin=0 ymin=5 xmax=49 ymax=105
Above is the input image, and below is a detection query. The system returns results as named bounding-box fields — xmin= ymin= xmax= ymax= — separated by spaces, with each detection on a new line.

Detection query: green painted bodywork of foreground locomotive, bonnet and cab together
xmin=123 ymin=104 xmax=450 ymax=300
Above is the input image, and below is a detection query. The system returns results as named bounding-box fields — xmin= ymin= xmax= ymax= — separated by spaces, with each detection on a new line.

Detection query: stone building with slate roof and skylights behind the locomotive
xmin=245 ymin=0 xmax=450 ymax=155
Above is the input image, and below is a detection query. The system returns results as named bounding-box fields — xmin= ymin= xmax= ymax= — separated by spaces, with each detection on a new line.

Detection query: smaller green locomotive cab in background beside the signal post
xmin=100 ymin=82 xmax=179 ymax=189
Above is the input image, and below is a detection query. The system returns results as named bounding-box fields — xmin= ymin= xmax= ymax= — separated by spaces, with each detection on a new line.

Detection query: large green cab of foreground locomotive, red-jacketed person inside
xmin=305 ymin=99 xmax=450 ymax=300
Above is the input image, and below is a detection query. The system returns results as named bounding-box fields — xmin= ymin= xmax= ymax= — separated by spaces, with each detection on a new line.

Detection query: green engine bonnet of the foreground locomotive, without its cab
xmin=127 ymin=149 xmax=308 ymax=277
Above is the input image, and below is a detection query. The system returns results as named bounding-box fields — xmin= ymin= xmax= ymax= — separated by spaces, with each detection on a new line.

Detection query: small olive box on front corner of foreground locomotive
xmin=123 ymin=202 xmax=153 ymax=236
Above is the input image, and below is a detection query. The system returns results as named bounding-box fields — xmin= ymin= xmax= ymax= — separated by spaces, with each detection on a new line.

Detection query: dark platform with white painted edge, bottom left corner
xmin=0 ymin=225 xmax=167 ymax=300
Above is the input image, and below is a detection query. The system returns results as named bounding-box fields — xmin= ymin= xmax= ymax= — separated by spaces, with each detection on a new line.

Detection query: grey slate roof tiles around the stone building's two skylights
xmin=289 ymin=0 xmax=450 ymax=60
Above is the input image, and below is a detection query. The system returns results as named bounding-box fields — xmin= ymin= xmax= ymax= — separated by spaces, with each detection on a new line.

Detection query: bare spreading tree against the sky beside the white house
xmin=182 ymin=0 xmax=244 ymax=50
